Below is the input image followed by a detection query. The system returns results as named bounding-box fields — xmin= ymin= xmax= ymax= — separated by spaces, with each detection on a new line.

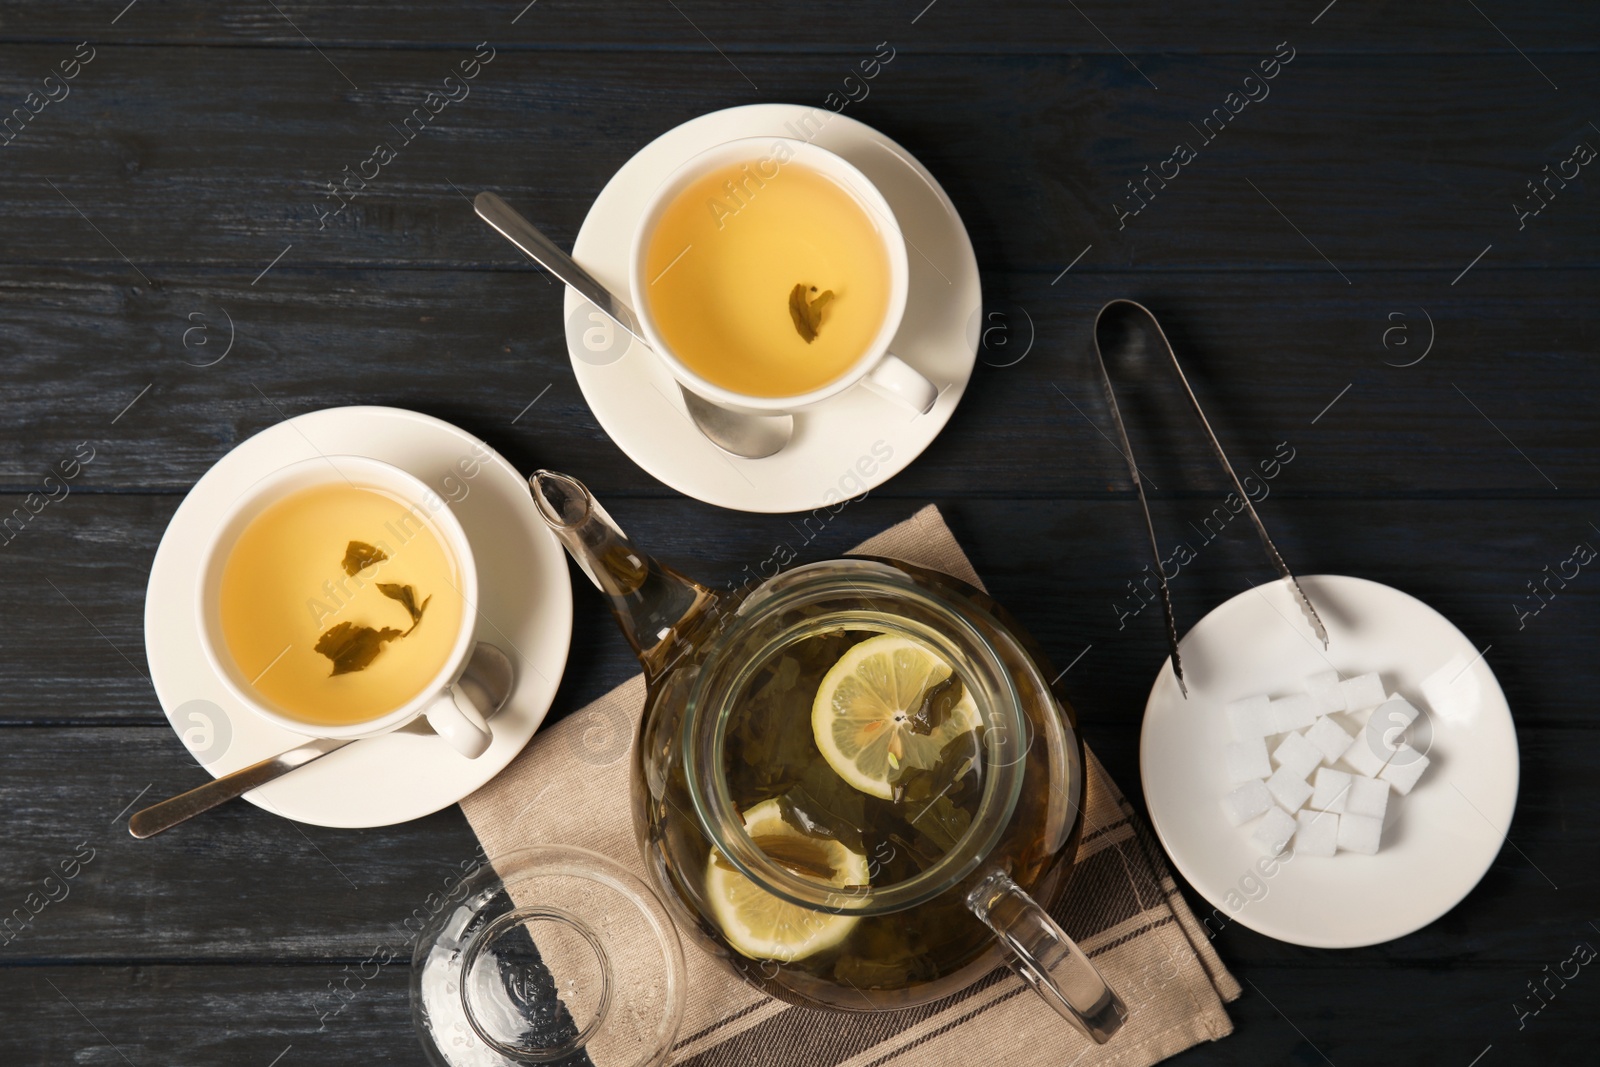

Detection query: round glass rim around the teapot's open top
xmin=683 ymin=558 xmax=1032 ymax=915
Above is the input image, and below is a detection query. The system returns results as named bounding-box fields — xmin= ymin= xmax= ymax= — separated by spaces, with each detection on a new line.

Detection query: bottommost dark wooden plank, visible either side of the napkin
xmin=0 ymin=953 xmax=1594 ymax=1067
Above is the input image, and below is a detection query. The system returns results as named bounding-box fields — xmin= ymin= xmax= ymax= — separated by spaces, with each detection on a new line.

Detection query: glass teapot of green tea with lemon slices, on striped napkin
xmin=530 ymin=470 xmax=1126 ymax=1041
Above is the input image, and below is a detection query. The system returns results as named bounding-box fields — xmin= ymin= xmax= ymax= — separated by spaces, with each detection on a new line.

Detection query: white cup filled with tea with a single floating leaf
xmin=630 ymin=138 xmax=938 ymax=414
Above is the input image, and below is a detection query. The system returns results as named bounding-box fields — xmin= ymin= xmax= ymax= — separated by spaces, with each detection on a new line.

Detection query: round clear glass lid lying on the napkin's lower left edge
xmin=411 ymin=845 xmax=686 ymax=1067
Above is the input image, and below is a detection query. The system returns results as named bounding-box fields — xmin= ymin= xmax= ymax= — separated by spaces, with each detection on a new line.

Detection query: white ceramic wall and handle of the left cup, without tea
xmin=197 ymin=456 xmax=493 ymax=758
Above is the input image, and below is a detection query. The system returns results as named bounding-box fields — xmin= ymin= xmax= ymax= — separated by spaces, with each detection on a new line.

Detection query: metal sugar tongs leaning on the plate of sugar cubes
xmin=1094 ymin=299 xmax=1328 ymax=699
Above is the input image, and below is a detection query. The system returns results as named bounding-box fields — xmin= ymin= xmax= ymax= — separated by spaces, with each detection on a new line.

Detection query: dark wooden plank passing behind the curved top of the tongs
xmin=0 ymin=271 xmax=1600 ymax=495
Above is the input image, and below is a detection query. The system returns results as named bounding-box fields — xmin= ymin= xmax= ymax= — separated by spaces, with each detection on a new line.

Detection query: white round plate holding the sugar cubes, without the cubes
xmin=1139 ymin=574 xmax=1518 ymax=949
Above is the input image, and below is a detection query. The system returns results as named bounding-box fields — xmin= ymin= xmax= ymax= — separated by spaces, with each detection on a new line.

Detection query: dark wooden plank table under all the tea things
xmin=0 ymin=0 xmax=1600 ymax=1067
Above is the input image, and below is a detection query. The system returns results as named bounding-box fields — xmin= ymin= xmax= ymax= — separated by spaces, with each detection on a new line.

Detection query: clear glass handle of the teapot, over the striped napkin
xmin=966 ymin=870 xmax=1128 ymax=1045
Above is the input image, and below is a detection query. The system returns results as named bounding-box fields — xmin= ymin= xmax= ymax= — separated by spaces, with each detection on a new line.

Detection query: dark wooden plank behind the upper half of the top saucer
xmin=0 ymin=49 xmax=1600 ymax=271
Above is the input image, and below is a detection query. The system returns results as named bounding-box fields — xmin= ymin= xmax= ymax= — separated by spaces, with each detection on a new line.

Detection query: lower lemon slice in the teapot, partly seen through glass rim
xmin=706 ymin=800 xmax=869 ymax=961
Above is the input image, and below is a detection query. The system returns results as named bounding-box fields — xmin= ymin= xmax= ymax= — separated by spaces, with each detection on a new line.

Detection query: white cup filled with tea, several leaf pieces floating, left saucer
xmin=198 ymin=456 xmax=491 ymax=757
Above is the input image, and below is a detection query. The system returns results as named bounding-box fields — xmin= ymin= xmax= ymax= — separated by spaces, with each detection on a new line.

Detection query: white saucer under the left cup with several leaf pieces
xmin=144 ymin=408 xmax=573 ymax=827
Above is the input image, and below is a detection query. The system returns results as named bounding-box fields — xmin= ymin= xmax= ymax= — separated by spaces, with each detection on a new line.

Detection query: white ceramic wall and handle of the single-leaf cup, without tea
xmin=629 ymin=138 xmax=939 ymax=414
